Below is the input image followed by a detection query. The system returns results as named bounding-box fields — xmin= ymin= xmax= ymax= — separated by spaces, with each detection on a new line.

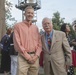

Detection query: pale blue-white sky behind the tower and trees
xmin=9 ymin=0 xmax=76 ymax=28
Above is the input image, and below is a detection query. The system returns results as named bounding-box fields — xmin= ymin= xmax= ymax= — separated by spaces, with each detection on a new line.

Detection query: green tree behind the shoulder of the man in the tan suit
xmin=52 ymin=11 xmax=65 ymax=30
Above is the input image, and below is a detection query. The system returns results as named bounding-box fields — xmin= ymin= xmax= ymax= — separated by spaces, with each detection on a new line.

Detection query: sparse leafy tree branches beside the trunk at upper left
xmin=5 ymin=0 xmax=17 ymax=28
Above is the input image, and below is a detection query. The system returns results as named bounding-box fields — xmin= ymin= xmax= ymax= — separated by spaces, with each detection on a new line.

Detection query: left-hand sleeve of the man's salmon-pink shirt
xmin=13 ymin=25 xmax=31 ymax=60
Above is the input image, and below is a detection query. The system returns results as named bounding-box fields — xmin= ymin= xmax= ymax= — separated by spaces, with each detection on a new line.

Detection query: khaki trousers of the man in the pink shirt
xmin=17 ymin=54 xmax=39 ymax=75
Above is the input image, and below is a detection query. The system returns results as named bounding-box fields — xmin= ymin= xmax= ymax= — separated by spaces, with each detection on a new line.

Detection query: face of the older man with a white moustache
xmin=42 ymin=19 xmax=53 ymax=33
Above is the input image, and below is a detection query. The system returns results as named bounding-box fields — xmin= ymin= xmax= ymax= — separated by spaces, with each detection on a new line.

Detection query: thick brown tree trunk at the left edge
xmin=0 ymin=0 xmax=6 ymax=40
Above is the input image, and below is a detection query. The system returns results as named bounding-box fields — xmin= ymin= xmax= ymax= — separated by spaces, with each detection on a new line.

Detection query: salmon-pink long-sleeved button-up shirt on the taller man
xmin=13 ymin=21 xmax=42 ymax=59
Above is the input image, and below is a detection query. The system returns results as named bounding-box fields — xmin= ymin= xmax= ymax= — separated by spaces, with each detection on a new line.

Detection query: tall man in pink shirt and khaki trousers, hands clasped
xmin=13 ymin=6 xmax=42 ymax=75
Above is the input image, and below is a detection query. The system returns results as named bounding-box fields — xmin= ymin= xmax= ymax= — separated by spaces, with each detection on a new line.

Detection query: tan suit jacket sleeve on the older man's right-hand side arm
xmin=62 ymin=33 xmax=72 ymax=65
